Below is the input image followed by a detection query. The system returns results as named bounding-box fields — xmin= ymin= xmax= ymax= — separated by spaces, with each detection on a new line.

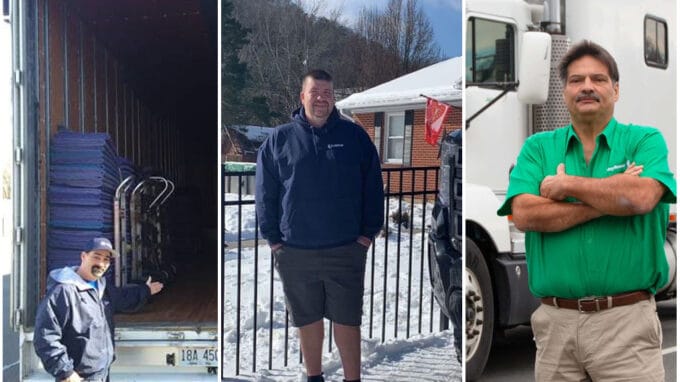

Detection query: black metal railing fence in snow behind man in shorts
xmin=221 ymin=167 xmax=440 ymax=378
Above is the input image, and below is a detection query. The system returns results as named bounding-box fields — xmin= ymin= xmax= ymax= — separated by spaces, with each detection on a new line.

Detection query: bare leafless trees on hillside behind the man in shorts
xmin=232 ymin=0 xmax=438 ymax=123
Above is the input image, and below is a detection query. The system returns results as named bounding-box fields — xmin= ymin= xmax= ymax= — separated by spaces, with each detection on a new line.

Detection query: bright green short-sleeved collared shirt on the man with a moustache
xmin=498 ymin=118 xmax=676 ymax=298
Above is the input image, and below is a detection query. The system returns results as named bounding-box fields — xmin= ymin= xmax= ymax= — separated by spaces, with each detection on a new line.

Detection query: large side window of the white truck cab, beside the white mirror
xmin=465 ymin=17 xmax=515 ymax=83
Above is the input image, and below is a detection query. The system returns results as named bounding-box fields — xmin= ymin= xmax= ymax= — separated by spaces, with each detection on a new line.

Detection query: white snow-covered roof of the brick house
xmin=336 ymin=57 xmax=463 ymax=115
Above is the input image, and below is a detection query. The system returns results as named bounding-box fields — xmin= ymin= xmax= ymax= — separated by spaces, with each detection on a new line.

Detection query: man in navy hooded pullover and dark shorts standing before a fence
xmin=255 ymin=70 xmax=384 ymax=381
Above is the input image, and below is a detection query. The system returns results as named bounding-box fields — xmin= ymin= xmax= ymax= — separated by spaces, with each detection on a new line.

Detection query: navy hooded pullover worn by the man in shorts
xmin=255 ymin=108 xmax=384 ymax=248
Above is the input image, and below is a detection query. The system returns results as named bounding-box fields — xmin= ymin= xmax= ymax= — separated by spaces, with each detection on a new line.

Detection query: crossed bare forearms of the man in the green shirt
xmin=512 ymin=163 xmax=664 ymax=232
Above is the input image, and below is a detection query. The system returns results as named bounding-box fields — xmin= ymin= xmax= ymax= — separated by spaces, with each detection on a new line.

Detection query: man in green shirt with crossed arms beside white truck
xmin=498 ymin=41 xmax=676 ymax=381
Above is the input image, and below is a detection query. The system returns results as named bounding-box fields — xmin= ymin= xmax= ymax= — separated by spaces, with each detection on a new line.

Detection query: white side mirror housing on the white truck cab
xmin=517 ymin=32 xmax=551 ymax=104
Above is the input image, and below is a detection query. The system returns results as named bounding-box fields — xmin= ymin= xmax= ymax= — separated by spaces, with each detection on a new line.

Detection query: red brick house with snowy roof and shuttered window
xmin=336 ymin=57 xmax=463 ymax=195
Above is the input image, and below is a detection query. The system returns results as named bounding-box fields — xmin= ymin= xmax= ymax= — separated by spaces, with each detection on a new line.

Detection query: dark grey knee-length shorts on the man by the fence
xmin=274 ymin=242 xmax=367 ymax=327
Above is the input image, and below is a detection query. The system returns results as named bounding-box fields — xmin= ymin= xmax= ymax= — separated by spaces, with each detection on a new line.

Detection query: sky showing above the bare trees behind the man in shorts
xmin=300 ymin=0 xmax=462 ymax=58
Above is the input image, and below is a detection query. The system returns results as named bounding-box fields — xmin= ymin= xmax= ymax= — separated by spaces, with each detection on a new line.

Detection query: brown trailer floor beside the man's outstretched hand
xmin=115 ymin=263 xmax=218 ymax=327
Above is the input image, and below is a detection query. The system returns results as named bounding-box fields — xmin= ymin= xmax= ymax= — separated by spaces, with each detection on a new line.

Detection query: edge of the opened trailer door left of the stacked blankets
xmin=8 ymin=0 xmax=40 ymax=331
